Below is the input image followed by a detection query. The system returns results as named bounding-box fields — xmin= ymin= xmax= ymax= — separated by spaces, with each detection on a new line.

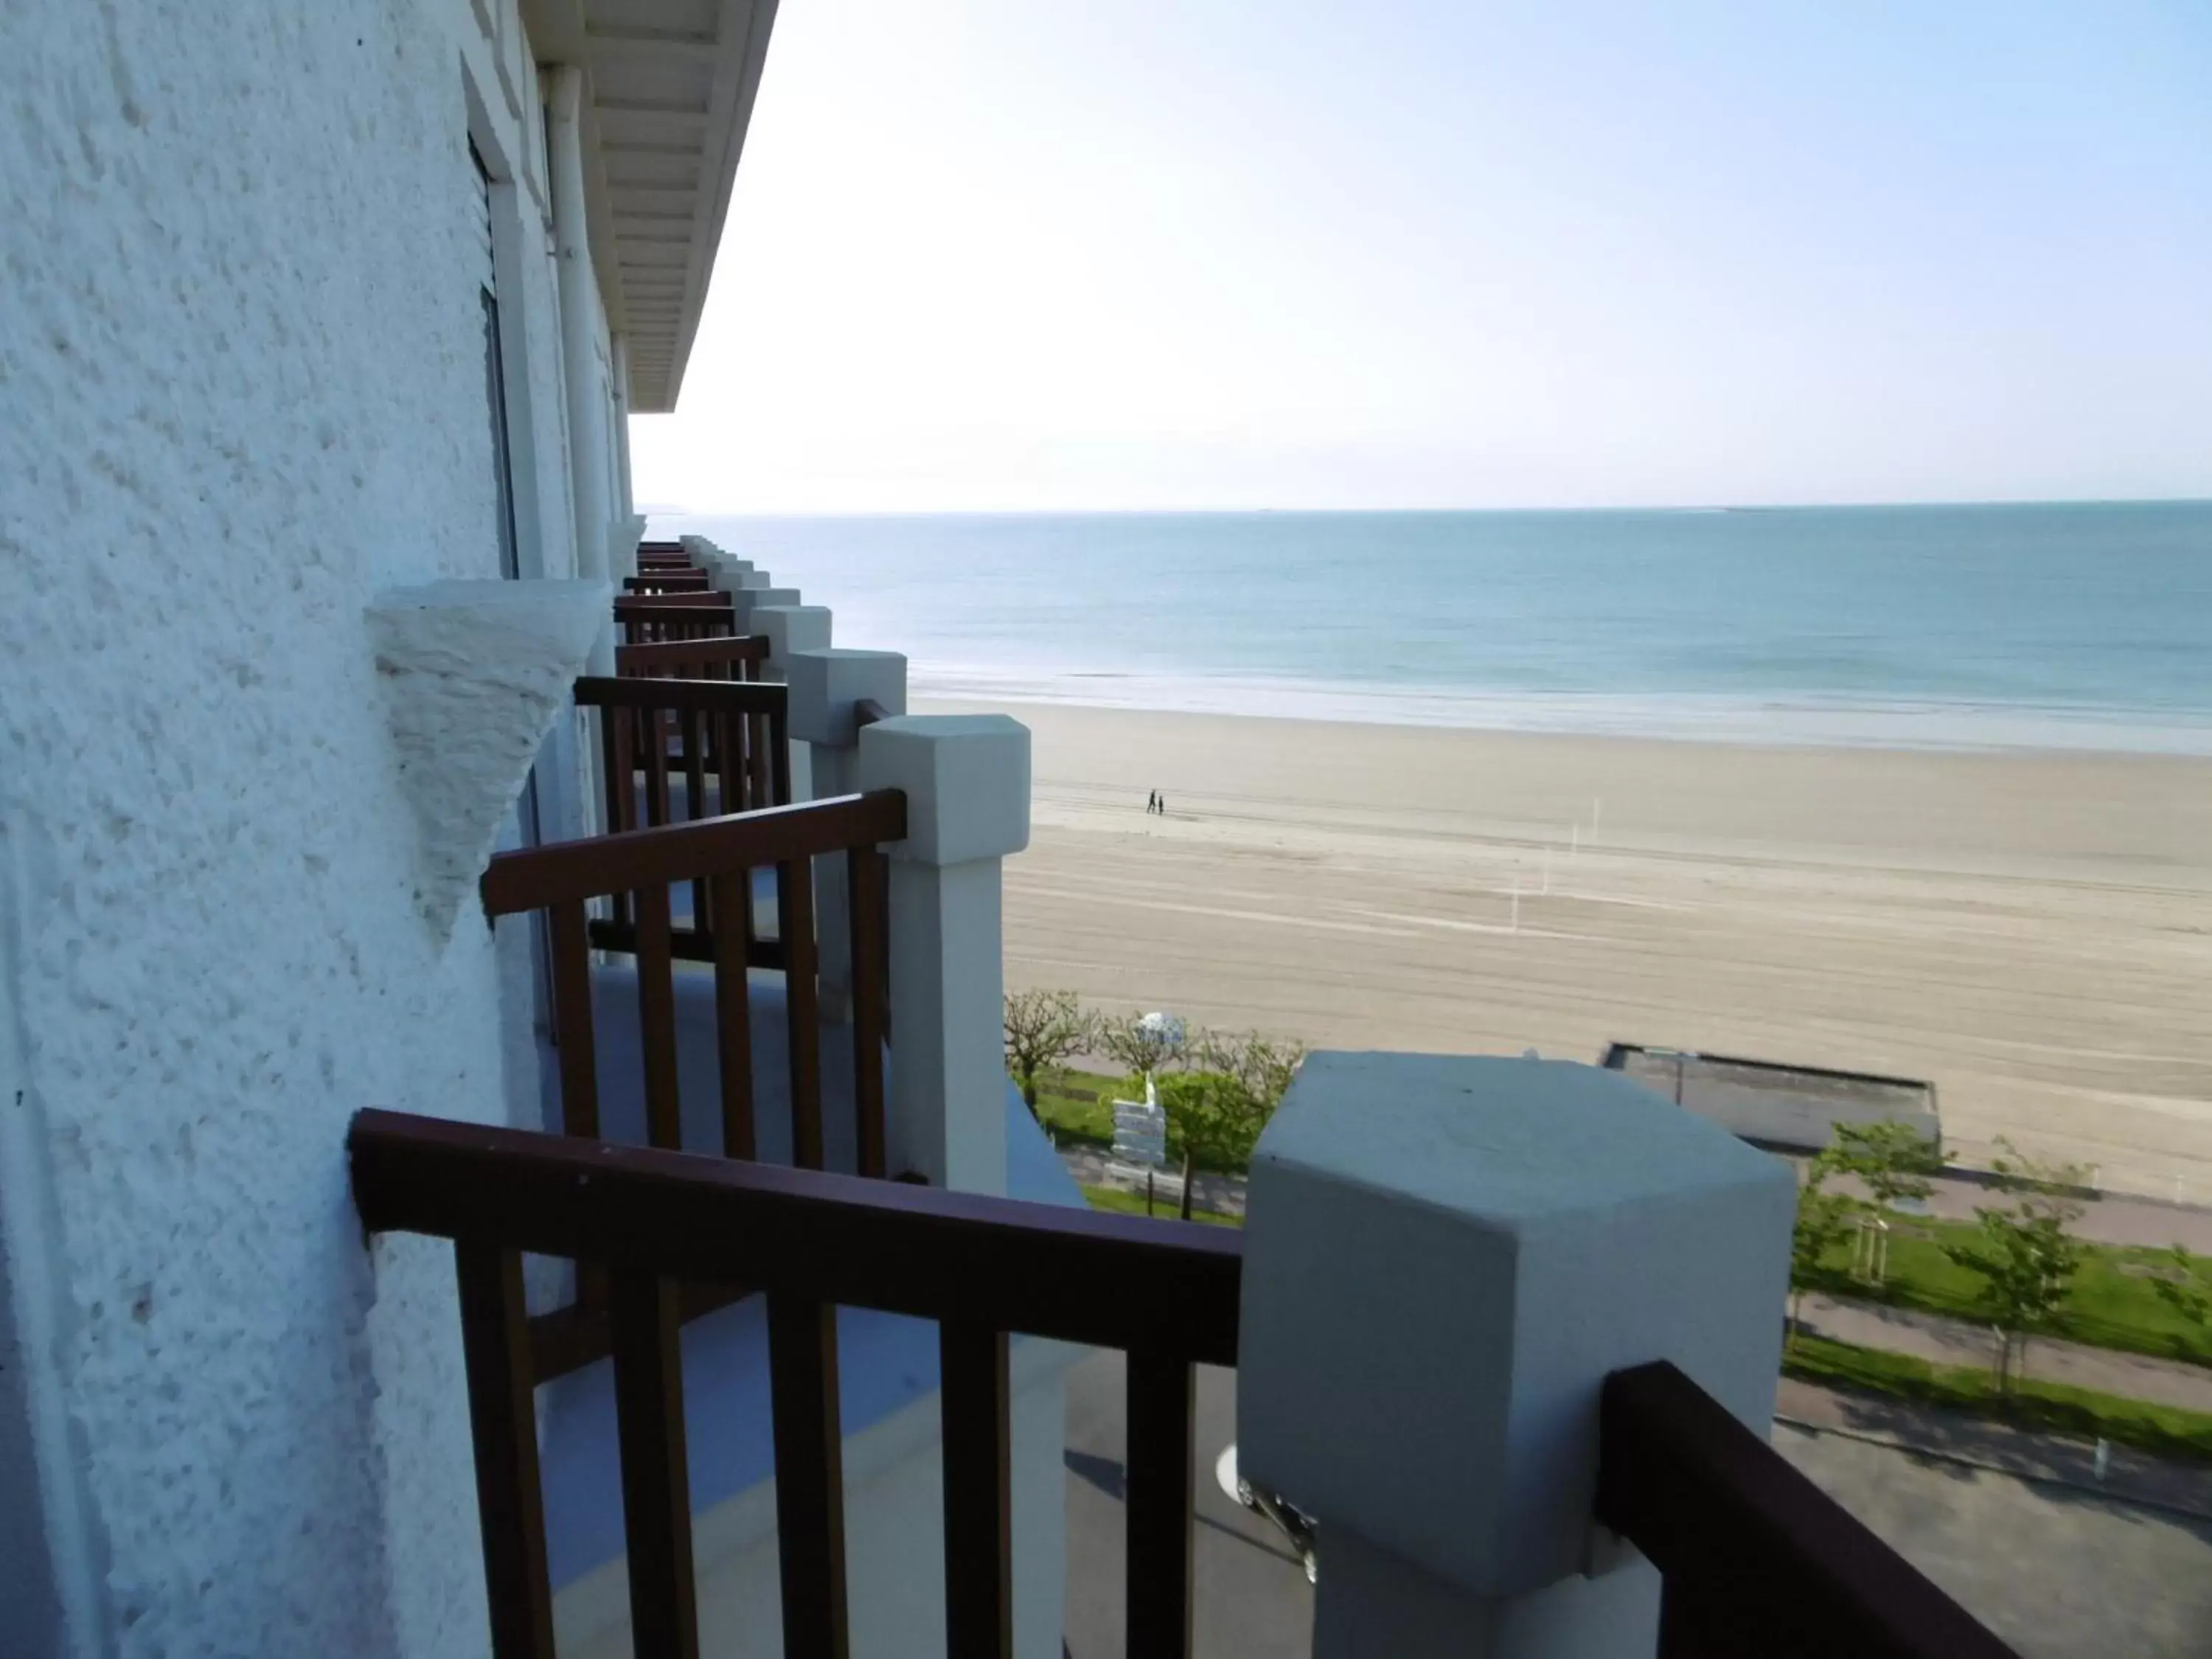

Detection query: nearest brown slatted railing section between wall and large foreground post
xmin=349 ymin=1113 xmax=1243 ymax=1659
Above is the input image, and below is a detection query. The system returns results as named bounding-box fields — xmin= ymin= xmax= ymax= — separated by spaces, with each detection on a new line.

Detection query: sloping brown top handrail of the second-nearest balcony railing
xmin=478 ymin=796 xmax=907 ymax=916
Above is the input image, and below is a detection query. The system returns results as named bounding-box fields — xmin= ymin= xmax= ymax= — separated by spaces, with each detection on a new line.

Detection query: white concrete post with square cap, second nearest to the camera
xmin=858 ymin=714 xmax=1029 ymax=1192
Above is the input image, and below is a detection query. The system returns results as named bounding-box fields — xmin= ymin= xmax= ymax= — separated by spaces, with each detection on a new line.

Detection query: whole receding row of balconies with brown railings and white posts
xmin=349 ymin=546 xmax=2006 ymax=1659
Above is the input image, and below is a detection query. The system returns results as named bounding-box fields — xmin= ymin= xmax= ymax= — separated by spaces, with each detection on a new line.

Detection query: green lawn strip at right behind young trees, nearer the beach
xmin=1818 ymin=1217 xmax=2212 ymax=1365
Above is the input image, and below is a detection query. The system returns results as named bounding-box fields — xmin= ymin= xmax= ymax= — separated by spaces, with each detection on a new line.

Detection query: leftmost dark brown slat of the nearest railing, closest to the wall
xmin=453 ymin=1241 xmax=553 ymax=1659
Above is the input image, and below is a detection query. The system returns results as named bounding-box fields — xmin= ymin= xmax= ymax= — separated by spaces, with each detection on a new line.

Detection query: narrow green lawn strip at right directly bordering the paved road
xmin=1783 ymin=1336 xmax=2212 ymax=1462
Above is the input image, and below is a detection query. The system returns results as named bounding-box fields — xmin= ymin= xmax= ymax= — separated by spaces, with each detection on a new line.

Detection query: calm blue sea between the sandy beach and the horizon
xmin=653 ymin=502 xmax=2212 ymax=754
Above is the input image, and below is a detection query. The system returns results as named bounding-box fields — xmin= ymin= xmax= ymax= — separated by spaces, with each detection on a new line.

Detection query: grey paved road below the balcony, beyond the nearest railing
xmin=1066 ymin=1354 xmax=2212 ymax=1659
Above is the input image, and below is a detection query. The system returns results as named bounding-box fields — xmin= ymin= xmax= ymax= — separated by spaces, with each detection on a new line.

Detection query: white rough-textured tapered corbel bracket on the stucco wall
xmin=367 ymin=582 xmax=613 ymax=942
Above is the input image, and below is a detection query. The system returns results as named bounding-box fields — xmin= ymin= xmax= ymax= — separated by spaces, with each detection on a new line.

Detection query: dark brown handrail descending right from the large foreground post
xmin=1597 ymin=1360 xmax=2017 ymax=1659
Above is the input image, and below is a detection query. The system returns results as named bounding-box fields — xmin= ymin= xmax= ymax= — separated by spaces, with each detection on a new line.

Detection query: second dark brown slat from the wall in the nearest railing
xmin=608 ymin=1272 xmax=699 ymax=1659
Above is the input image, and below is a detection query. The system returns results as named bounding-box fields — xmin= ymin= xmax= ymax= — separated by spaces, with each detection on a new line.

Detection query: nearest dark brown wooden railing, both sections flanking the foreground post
xmin=349 ymin=1113 xmax=2011 ymax=1659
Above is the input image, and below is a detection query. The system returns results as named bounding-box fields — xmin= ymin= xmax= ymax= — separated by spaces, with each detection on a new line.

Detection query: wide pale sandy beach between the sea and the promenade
xmin=927 ymin=703 xmax=2212 ymax=1203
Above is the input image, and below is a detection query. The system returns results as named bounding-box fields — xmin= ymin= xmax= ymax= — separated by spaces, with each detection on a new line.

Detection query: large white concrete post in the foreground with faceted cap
xmin=1237 ymin=1053 xmax=1796 ymax=1659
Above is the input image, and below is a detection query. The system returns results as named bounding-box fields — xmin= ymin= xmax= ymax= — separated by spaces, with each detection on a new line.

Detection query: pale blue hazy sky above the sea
xmin=630 ymin=0 xmax=2212 ymax=513
